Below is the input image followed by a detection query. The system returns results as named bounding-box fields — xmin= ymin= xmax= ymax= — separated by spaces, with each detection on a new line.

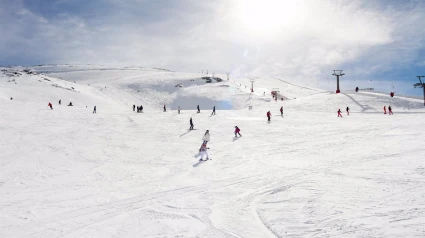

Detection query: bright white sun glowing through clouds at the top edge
xmin=233 ymin=0 xmax=299 ymax=34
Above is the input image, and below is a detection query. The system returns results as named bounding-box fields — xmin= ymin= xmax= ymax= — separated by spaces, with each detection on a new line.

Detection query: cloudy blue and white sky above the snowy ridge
xmin=0 ymin=0 xmax=425 ymax=94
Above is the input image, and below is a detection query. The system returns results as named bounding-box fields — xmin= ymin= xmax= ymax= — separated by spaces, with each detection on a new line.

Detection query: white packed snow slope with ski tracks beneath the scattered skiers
xmin=0 ymin=65 xmax=425 ymax=238
